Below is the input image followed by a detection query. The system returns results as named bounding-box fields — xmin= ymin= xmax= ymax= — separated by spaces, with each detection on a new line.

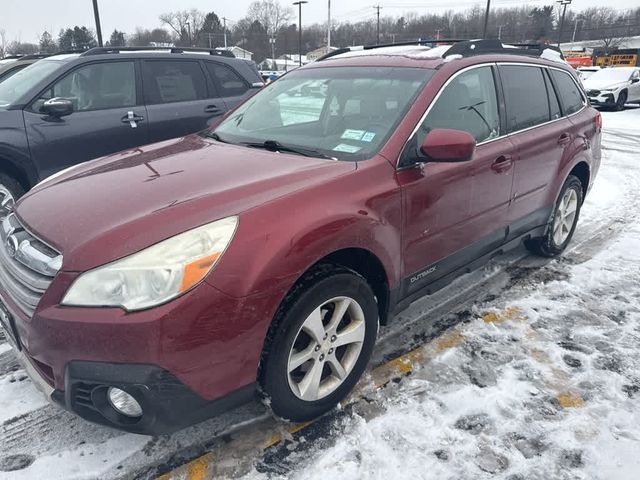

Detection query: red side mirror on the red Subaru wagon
xmin=420 ymin=128 xmax=476 ymax=162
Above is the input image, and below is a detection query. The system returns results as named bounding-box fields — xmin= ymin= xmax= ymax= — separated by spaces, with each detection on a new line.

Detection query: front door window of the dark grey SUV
xmin=33 ymin=62 xmax=136 ymax=112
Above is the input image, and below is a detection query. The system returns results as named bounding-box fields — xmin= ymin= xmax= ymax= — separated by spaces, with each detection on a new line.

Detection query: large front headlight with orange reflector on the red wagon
xmin=62 ymin=217 xmax=238 ymax=311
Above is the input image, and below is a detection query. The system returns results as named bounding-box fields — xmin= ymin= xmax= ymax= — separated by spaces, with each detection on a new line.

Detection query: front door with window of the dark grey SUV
xmin=24 ymin=60 xmax=147 ymax=178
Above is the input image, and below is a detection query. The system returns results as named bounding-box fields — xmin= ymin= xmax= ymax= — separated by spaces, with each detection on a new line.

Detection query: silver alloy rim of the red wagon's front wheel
xmin=287 ymin=297 xmax=366 ymax=402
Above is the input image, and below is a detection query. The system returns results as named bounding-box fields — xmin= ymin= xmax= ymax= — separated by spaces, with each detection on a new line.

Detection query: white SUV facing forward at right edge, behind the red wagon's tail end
xmin=583 ymin=67 xmax=640 ymax=110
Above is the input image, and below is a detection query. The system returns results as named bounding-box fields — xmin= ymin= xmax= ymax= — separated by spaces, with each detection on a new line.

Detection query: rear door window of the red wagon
xmin=499 ymin=65 xmax=550 ymax=133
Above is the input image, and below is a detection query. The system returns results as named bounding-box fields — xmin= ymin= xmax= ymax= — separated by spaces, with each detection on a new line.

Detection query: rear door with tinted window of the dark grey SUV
xmin=142 ymin=59 xmax=227 ymax=142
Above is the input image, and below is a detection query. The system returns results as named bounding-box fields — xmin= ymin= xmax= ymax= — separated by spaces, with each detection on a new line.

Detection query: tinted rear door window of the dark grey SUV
xmin=143 ymin=60 xmax=207 ymax=105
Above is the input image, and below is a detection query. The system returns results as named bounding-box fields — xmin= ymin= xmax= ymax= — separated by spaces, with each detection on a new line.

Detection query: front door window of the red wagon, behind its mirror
xmin=417 ymin=67 xmax=500 ymax=145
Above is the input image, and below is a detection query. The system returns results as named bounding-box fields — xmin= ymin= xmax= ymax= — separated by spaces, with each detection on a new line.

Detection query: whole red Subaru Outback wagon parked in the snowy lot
xmin=0 ymin=41 xmax=601 ymax=434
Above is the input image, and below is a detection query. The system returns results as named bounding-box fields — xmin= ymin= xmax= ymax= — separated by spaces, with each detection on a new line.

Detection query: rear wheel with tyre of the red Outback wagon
xmin=527 ymin=175 xmax=583 ymax=257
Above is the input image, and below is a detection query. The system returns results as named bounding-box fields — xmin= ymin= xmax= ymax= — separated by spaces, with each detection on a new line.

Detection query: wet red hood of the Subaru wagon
xmin=15 ymin=135 xmax=356 ymax=271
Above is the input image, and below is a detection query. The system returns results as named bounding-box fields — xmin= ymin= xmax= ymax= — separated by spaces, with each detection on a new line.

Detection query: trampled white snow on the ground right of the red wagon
xmin=239 ymin=110 xmax=640 ymax=480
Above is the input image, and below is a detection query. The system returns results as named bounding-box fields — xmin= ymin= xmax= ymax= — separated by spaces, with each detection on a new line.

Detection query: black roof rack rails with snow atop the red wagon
xmin=317 ymin=38 xmax=564 ymax=62
